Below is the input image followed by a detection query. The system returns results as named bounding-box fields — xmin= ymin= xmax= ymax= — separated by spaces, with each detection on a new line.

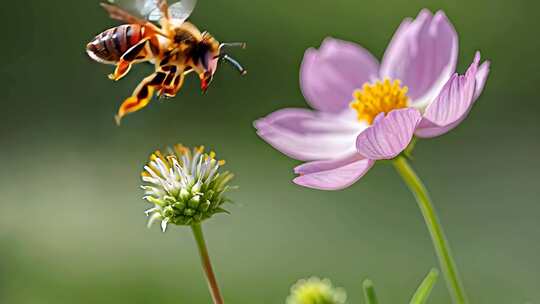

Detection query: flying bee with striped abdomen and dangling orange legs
xmin=86 ymin=0 xmax=246 ymax=124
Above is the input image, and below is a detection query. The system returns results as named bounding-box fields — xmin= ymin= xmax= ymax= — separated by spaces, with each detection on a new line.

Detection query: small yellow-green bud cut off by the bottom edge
xmin=286 ymin=277 xmax=347 ymax=304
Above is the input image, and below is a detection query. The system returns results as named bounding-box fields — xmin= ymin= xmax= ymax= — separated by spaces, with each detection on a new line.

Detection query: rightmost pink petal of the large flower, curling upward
xmin=416 ymin=52 xmax=489 ymax=137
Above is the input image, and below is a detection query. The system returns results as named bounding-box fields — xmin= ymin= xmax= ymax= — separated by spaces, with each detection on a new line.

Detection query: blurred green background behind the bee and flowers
xmin=0 ymin=0 xmax=540 ymax=304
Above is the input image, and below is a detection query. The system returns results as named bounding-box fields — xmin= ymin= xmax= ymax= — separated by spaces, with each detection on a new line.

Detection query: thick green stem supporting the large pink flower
xmin=393 ymin=156 xmax=468 ymax=304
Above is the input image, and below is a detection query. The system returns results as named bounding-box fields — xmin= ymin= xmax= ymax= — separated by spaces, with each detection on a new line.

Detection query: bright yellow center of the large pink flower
xmin=351 ymin=79 xmax=409 ymax=125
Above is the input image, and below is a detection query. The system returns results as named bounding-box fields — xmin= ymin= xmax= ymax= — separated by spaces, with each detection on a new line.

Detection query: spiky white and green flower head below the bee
xmin=142 ymin=144 xmax=233 ymax=231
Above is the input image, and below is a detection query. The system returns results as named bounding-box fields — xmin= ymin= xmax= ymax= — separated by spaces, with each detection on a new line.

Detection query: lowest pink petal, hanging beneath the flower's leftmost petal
xmin=293 ymin=153 xmax=375 ymax=190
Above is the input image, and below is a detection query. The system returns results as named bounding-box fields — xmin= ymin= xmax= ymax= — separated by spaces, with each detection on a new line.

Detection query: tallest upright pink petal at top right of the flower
xmin=381 ymin=10 xmax=458 ymax=103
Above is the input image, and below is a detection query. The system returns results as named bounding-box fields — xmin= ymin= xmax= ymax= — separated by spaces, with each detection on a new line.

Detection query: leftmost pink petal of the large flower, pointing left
xmin=255 ymin=109 xmax=365 ymax=161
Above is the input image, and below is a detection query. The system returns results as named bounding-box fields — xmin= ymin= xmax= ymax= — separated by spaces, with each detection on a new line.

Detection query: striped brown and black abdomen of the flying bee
xmin=86 ymin=24 xmax=149 ymax=64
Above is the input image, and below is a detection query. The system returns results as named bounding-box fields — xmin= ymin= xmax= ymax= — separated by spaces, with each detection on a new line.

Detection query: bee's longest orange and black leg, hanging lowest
xmin=115 ymin=72 xmax=167 ymax=125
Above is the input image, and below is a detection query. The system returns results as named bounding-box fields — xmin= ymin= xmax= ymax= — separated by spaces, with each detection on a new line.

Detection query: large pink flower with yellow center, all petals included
xmin=255 ymin=10 xmax=489 ymax=190
